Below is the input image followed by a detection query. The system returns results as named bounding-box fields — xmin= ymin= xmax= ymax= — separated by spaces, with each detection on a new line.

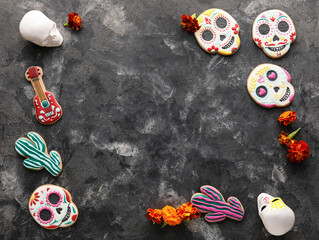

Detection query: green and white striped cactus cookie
xmin=15 ymin=132 xmax=62 ymax=177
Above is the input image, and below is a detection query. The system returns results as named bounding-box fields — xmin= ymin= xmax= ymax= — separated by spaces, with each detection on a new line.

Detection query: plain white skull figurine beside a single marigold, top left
xmin=19 ymin=10 xmax=63 ymax=47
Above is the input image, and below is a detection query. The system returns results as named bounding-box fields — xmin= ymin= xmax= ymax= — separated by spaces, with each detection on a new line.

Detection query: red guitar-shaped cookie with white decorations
xmin=25 ymin=66 xmax=62 ymax=125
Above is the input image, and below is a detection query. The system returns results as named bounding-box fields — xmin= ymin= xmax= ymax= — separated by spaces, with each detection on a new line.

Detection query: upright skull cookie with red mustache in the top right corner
xmin=252 ymin=10 xmax=296 ymax=58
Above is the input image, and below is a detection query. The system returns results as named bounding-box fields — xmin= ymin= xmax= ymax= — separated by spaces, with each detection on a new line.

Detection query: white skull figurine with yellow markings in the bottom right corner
xmin=257 ymin=193 xmax=295 ymax=236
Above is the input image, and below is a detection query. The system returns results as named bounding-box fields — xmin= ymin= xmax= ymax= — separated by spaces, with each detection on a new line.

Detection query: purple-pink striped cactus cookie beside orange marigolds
xmin=191 ymin=185 xmax=245 ymax=222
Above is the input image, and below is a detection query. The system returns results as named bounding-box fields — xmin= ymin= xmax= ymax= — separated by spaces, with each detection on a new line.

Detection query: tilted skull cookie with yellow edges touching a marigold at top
xmin=194 ymin=8 xmax=240 ymax=55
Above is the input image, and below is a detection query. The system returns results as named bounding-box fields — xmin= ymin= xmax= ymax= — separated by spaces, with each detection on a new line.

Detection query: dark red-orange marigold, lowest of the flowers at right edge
xmin=287 ymin=140 xmax=310 ymax=163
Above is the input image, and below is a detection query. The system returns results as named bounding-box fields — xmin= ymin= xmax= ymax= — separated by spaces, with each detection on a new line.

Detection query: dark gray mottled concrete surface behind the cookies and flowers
xmin=0 ymin=0 xmax=319 ymax=240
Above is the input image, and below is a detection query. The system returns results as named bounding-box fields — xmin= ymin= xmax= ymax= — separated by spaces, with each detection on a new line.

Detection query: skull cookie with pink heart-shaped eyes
xmin=247 ymin=63 xmax=295 ymax=108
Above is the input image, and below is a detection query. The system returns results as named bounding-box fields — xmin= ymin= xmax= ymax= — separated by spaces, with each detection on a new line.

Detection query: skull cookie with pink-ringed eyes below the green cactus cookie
xmin=29 ymin=185 xmax=79 ymax=230
